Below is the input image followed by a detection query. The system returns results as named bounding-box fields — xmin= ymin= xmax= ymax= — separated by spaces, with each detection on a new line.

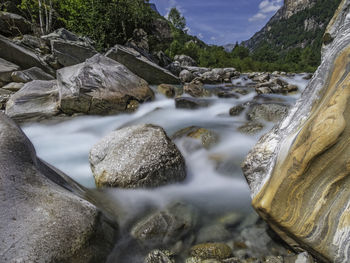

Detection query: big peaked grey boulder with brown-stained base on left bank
xmin=57 ymin=54 xmax=154 ymax=114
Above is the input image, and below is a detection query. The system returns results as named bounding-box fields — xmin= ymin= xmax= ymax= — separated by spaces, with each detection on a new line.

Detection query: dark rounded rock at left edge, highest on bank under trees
xmin=0 ymin=11 xmax=32 ymax=37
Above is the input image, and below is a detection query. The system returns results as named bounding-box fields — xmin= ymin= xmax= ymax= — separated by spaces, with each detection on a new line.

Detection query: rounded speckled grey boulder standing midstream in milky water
xmin=89 ymin=125 xmax=186 ymax=188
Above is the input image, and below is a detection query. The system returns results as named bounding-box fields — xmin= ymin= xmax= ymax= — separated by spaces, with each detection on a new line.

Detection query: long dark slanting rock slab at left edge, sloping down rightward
xmin=0 ymin=35 xmax=55 ymax=75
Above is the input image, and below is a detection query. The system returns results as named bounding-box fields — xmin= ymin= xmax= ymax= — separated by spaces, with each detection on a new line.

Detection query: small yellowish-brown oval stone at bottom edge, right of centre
xmin=190 ymin=243 xmax=232 ymax=260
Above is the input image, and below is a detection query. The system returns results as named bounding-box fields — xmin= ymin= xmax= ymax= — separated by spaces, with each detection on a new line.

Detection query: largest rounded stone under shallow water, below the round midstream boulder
xmin=131 ymin=203 xmax=197 ymax=246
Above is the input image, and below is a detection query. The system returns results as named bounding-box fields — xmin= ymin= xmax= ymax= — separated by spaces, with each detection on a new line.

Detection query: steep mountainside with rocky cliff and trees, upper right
xmin=243 ymin=0 xmax=341 ymax=53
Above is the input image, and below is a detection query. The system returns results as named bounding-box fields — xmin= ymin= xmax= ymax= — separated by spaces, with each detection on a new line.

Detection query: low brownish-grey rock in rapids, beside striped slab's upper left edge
xmin=247 ymin=103 xmax=288 ymax=122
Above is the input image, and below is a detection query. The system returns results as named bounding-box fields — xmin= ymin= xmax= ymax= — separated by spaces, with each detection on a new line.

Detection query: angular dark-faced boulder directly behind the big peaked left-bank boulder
xmin=42 ymin=28 xmax=97 ymax=67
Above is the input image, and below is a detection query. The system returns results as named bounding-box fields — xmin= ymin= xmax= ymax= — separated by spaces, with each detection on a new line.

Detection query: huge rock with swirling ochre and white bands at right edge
xmin=243 ymin=0 xmax=350 ymax=263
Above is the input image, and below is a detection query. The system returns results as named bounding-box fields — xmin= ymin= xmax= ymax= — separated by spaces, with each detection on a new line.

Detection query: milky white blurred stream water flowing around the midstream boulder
xmin=23 ymin=75 xmax=308 ymax=262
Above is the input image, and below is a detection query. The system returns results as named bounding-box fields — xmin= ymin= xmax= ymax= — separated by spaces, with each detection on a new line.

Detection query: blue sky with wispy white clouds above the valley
xmin=150 ymin=0 xmax=283 ymax=45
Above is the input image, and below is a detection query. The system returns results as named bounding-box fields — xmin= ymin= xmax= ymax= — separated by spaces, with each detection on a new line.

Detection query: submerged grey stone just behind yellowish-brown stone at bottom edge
xmin=196 ymin=224 xmax=231 ymax=243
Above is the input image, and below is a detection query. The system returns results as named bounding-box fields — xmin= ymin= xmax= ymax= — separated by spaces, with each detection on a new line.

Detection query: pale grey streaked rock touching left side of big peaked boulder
xmin=6 ymin=80 xmax=60 ymax=122
